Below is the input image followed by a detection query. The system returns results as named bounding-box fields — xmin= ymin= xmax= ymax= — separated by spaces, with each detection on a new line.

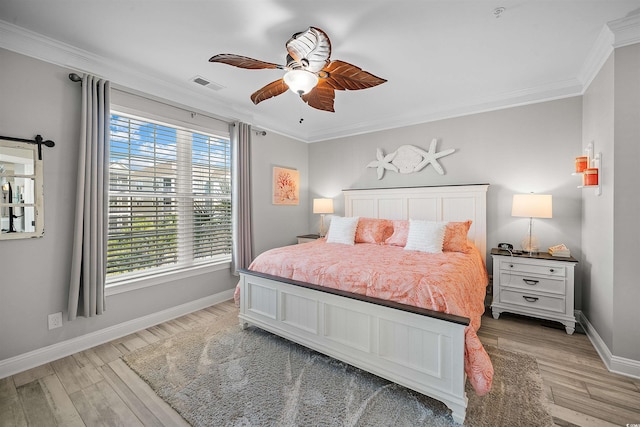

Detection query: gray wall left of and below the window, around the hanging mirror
xmin=0 ymin=49 xmax=235 ymax=360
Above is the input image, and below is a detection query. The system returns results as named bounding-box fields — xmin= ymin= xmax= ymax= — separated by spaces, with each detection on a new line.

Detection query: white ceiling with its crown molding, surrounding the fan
xmin=0 ymin=0 xmax=640 ymax=142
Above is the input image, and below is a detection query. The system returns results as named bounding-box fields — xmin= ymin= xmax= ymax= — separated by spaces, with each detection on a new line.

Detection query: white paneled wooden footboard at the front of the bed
xmin=239 ymin=270 xmax=468 ymax=423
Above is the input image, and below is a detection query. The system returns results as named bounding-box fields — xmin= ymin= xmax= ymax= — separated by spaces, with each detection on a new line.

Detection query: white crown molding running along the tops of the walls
xmin=0 ymin=15 xmax=640 ymax=142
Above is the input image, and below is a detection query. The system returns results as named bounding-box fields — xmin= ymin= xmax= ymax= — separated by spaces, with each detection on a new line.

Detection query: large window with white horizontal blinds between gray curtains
xmin=107 ymin=113 xmax=231 ymax=280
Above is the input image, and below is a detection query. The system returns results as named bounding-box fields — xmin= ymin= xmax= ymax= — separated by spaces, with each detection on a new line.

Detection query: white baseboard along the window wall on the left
xmin=0 ymin=289 xmax=235 ymax=379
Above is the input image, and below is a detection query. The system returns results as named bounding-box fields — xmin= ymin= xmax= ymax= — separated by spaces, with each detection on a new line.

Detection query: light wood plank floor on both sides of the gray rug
xmin=0 ymin=301 xmax=640 ymax=427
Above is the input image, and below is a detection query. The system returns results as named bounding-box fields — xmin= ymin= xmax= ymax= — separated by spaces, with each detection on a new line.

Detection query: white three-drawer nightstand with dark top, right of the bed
xmin=491 ymin=248 xmax=578 ymax=334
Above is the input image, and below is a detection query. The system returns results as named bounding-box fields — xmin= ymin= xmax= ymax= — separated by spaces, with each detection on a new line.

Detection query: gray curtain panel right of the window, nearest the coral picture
xmin=229 ymin=122 xmax=253 ymax=276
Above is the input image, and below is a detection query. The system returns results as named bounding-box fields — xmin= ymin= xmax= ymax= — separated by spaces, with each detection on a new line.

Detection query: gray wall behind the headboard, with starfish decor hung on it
xmin=309 ymin=97 xmax=582 ymax=294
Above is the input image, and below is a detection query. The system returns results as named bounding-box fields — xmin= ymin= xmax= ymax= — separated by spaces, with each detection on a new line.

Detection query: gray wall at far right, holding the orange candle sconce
xmin=581 ymin=44 xmax=640 ymax=360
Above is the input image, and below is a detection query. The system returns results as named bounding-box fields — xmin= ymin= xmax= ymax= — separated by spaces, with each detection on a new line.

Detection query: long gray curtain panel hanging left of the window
xmin=69 ymin=75 xmax=110 ymax=320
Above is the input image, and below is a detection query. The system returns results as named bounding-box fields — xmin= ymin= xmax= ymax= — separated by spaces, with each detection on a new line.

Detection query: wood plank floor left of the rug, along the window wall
xmin=0 ymin=301 xmax=237 ymax=427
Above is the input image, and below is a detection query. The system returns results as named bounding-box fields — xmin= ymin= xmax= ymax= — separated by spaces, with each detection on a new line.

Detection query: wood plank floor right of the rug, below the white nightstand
xmin=478 ymin=313 xmax=640 ymax=427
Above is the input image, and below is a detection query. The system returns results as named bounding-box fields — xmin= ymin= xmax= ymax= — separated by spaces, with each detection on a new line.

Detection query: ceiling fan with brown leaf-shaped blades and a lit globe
xmin=209 ymin=27 xmax=386 ymax=112
